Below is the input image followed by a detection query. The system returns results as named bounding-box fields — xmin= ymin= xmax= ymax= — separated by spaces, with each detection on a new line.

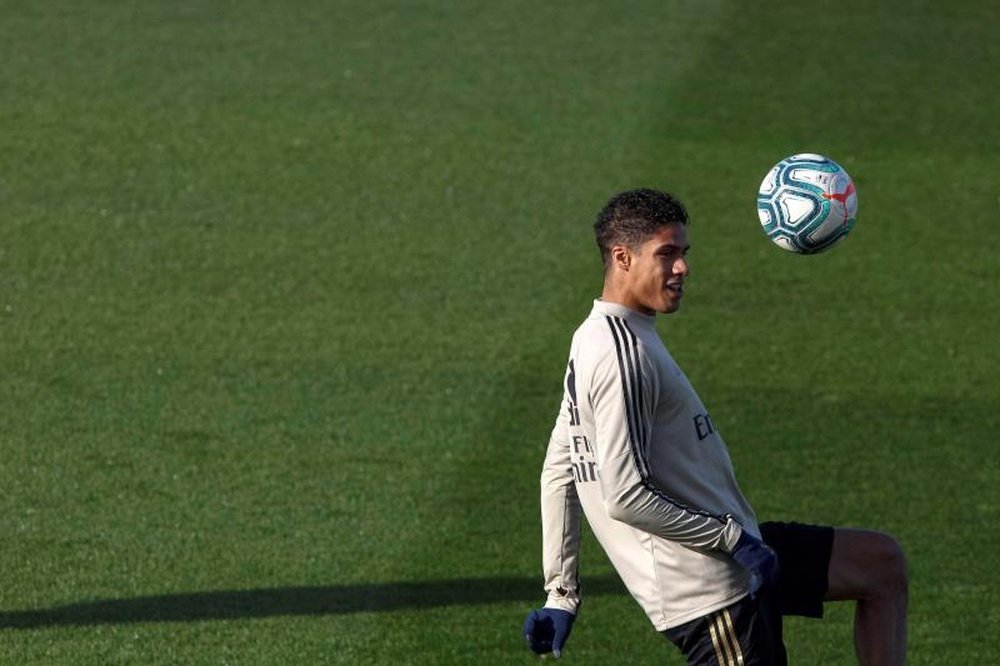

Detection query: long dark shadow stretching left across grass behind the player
xmin=0 ymin=576 xmax=625 ymax=629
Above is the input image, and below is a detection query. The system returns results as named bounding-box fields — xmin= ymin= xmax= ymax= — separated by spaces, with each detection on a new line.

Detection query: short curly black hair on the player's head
xmin=594 ymin=188 xmax=688 ymax=270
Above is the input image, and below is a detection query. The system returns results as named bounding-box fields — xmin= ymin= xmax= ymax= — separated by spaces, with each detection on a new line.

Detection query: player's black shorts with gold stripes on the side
xmin=663 ymin=523 xmax=833 ymax=666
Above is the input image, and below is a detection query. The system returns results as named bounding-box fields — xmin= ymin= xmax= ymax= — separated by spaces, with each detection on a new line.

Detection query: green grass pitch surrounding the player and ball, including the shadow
xmin=0 ymin=0 xmax=1000 ymax=666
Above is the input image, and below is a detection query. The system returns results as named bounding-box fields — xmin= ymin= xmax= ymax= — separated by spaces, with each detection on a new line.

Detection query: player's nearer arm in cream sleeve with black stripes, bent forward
xmin=589 ymin=347 xmax=743 ymax=553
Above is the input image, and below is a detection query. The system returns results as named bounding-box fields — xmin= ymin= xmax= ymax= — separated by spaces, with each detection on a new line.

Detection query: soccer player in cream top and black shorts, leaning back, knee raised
xmin=523 ymin=189 xmax=907 ymax=666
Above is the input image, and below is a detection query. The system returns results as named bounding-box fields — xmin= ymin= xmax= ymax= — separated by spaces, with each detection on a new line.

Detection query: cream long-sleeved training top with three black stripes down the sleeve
xmin=541 ymin=300 xmax=760 ymax=631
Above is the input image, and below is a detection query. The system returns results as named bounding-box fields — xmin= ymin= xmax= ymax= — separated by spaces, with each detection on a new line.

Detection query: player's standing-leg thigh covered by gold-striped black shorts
xmin=663 ymin=595 xmax=788 ymax=666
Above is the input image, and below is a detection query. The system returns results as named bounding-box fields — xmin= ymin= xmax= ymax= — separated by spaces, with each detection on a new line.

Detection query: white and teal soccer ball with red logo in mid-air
xmin=757 ymin=153 xmax=858 ymax=254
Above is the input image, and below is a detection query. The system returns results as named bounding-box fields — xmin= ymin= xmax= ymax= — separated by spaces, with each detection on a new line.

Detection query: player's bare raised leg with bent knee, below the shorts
xmin=826 ymin=528 xmax=908 ymax=666
